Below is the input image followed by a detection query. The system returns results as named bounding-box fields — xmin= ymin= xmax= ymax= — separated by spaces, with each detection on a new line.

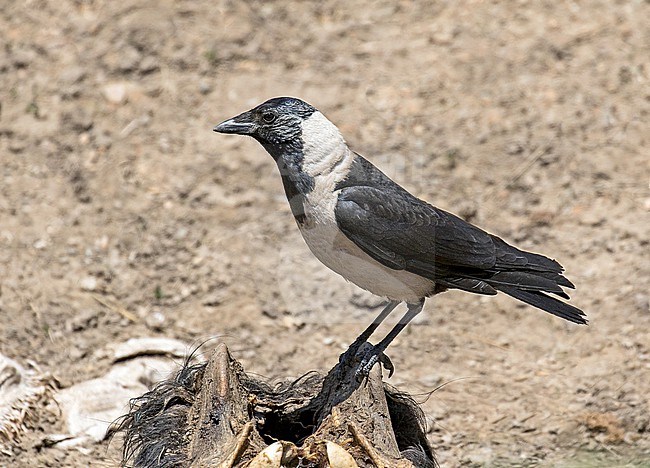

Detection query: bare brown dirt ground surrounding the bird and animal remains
xmin=0 ymin=0 xmax=650 ymax=467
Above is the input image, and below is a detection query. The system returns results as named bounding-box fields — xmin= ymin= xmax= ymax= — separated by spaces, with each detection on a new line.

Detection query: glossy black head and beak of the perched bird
xmin=214 ymin=97 xmax=316 ymax=159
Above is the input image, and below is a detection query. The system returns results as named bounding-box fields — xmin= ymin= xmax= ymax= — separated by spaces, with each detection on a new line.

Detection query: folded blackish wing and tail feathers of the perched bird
xmin=335 ymin=185 xmax=586 ymax=323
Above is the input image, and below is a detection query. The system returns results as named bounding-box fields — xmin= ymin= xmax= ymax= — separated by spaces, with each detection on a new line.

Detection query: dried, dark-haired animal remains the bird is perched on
xmin=111 ymin=343 xmax=436 ymax=468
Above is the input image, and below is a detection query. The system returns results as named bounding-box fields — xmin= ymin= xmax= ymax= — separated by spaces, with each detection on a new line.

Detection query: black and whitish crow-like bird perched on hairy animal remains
xmin=213 ymin=97 xmax=588 ymax=377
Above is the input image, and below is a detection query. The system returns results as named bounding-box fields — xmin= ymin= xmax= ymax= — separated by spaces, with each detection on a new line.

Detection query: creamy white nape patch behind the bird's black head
xmin=302 ymin=111 xmax=352 ymax=177
